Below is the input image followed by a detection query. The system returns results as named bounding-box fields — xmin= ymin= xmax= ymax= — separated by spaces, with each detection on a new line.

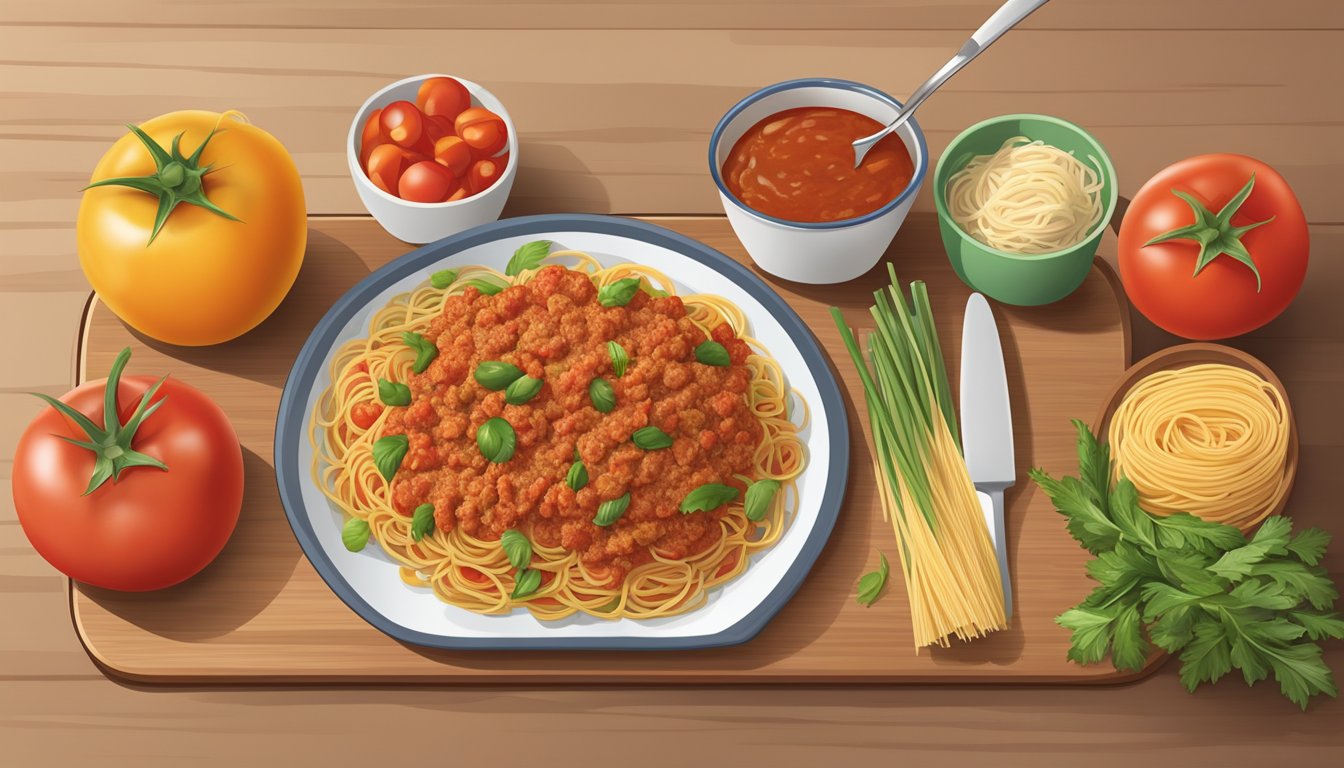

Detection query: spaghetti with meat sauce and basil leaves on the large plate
xmin=310 ymin=246 xmax=806 ymax=619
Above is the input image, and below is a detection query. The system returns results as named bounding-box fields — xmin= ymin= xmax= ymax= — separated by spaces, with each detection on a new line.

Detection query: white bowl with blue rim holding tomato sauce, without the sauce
xmin=710 ymin=78 xmax=929 ymax=284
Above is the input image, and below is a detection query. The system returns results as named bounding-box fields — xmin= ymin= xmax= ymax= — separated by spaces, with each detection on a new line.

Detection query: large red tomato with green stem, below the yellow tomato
xmin=13 ymin=348 xmax=243 ymax=592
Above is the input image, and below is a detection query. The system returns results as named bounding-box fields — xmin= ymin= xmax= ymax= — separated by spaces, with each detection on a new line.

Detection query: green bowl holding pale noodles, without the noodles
xmin=933 ymin=114 xmax=1116 ymax=307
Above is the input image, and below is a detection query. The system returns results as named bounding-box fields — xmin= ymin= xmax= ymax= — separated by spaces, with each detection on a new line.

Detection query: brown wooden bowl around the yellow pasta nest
xmin=1094 ymin=343 xmax=1298 ymax=515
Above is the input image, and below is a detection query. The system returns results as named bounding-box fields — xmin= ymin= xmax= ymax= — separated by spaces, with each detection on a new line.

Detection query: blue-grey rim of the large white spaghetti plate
xmin=276 ymin=214 xmax=849 ymax=651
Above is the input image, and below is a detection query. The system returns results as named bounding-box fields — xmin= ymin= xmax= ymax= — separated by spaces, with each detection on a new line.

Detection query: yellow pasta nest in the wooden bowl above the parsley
xmin=1109 ymin=363 xmax=1290 ymax=531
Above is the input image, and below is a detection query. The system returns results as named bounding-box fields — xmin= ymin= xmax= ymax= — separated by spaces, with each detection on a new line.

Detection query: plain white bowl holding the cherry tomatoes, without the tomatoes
xmin=345 ymin=74 xmax=519 ymax=245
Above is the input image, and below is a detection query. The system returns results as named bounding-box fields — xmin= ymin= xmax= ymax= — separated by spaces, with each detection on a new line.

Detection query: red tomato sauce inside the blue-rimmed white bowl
xmin=723 ymin=106 xmax=914 ymax=222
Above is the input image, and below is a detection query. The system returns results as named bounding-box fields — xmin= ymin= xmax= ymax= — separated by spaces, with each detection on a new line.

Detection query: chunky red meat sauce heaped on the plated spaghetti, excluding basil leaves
xmin=383 ymin=266 xmax=762 ymax=582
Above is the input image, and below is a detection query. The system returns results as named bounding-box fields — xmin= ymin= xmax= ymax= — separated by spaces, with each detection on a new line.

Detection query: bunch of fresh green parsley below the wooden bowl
xmin=1031 ymin=420 xmax=1344 ymax=709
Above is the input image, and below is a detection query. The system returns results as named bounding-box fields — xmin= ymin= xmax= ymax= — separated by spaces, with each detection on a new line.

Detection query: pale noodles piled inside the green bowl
xmin=946 ymin=136 xmax=1102 ymax=254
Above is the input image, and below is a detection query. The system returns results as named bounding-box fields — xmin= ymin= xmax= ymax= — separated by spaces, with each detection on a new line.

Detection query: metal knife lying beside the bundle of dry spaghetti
xmin=961 ymin=293 xmax=1017 ymax=616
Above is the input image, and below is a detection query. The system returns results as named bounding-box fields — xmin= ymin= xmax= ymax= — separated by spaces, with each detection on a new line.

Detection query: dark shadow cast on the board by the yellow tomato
xmin=128 ymin=229 xmax=373 ymax=387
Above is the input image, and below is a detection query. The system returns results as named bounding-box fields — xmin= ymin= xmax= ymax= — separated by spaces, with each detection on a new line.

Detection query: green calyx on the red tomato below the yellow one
xmin=32 ymin=347 xmax=168 ymax=496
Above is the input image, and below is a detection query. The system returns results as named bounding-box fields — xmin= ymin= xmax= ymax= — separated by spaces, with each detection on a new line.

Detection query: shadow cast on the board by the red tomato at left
xmin=77 ymin=448 xmax=302 ymax=642
